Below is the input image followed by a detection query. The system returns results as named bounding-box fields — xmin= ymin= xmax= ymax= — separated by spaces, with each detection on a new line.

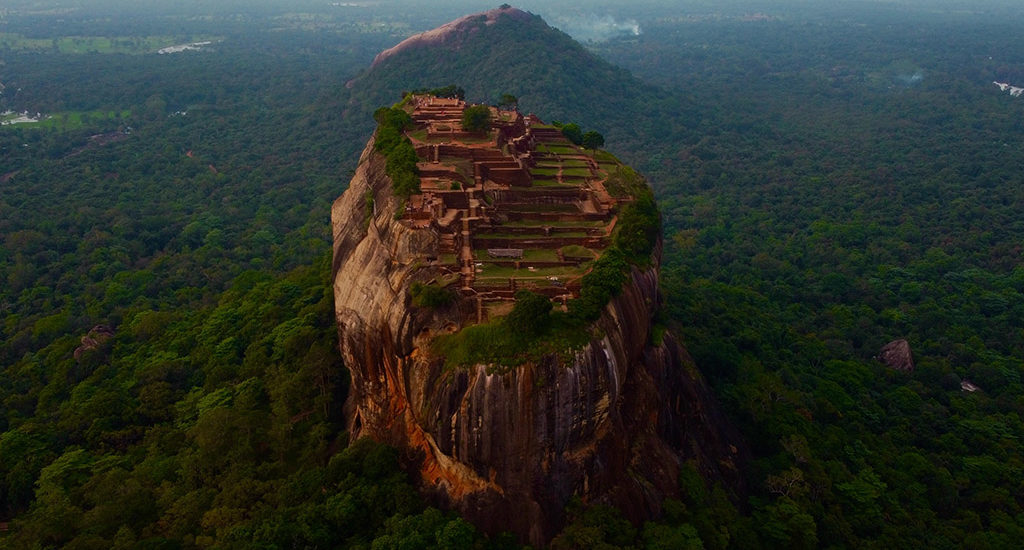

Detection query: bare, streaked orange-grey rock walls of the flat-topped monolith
xmin=332 ymin=140 xmax=739 ymax=545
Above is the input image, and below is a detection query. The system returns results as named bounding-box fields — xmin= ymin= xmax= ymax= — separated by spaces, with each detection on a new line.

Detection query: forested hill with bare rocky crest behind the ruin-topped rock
xmin=348 ymin=7 xmax=698 ymax=169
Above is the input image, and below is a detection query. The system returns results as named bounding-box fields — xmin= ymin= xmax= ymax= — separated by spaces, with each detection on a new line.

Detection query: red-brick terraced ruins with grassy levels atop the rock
xmin=401 ymin=95 xmax=631 ymax=323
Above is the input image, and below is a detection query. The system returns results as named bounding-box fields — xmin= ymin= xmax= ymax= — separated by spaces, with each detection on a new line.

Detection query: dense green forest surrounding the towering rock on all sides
xmin=0 ymin=0 xmax=1024 ymax=548
